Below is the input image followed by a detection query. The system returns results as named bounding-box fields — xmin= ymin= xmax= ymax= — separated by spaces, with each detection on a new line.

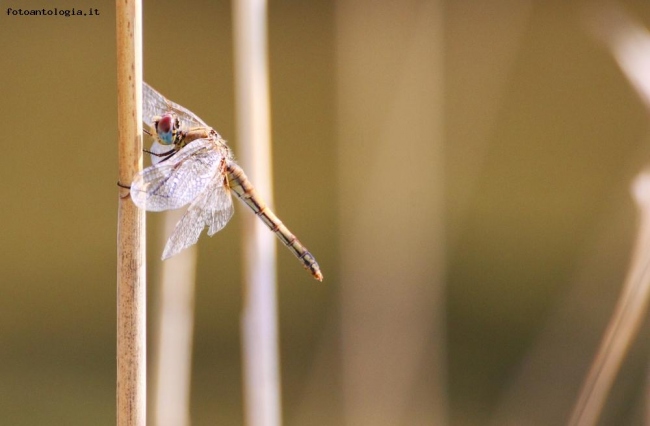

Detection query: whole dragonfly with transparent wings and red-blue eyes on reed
xmin=130 ymin=83 xmax=323 ymax=281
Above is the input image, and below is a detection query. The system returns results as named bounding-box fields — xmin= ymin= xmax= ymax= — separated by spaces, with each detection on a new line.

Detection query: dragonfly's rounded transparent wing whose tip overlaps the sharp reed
xmin=131 ymin=139 xmax=223 ymax=211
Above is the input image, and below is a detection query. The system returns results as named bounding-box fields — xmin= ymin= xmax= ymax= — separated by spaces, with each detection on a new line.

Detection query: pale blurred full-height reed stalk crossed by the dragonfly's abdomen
xmin=233 ymin=0 xmax=281 ymax=426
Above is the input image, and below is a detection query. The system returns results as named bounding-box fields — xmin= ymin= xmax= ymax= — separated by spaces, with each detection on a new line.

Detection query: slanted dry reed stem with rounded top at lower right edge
xmin=569 ymin=172 xmax=650 ymax=426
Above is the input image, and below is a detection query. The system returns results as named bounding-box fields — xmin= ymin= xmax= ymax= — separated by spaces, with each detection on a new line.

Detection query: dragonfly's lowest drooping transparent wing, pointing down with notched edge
xmin=162 ymin=179 xmax=234 ymax=260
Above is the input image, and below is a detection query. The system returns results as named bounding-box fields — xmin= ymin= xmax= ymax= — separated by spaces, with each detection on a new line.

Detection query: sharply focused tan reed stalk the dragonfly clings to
xmin=116 ymin=0 xmax=146 ymax=426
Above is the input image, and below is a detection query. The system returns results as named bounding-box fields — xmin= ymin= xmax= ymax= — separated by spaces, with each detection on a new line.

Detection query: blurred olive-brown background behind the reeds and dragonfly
xmin=0 ymin=0 xmax=650 ymax=426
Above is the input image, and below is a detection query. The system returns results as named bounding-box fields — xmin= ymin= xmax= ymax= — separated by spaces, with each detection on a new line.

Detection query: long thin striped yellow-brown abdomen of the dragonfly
xmin=226 ymin=161 xmax=323 ymax=281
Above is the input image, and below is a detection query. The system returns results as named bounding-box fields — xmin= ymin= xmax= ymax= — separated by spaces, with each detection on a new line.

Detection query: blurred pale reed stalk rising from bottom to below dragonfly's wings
xmin=153 ymin=209 xmax=198 ymax=426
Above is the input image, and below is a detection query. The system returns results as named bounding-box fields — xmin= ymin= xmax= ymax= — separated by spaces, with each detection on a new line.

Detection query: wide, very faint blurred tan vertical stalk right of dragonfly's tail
xmin=336 ymin=0 xmax=448 ymax=426
